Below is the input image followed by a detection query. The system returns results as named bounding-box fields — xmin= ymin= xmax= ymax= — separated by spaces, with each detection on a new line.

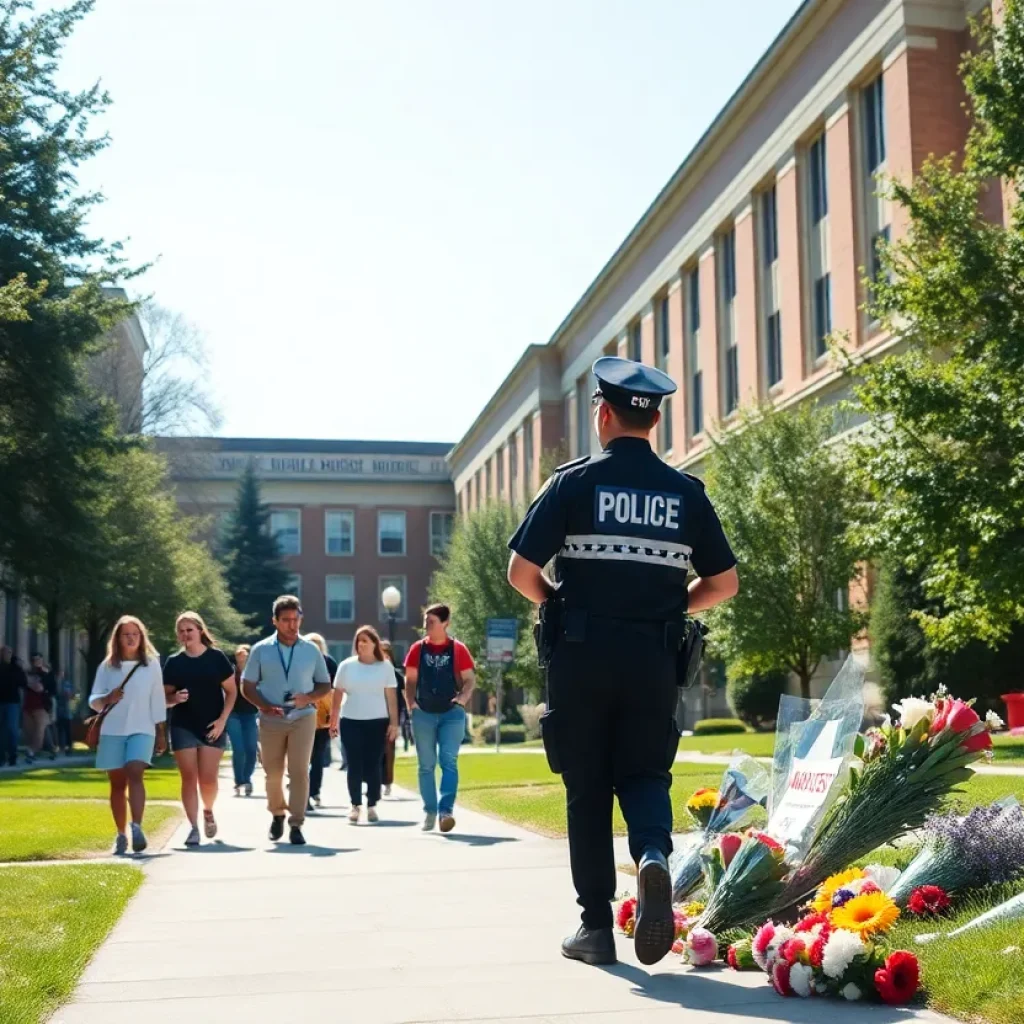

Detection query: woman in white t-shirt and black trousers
xmin=331 ymin=626 xmax=398 ymax=824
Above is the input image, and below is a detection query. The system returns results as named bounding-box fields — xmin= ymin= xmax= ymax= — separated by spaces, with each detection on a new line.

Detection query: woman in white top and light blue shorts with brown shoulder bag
xmin=89 ymin=615 xmax=167 ymax=855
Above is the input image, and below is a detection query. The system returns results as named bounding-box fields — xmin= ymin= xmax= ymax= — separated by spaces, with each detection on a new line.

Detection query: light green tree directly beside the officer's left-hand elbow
xmin=430 ymin=502 xmax=543 ymax=695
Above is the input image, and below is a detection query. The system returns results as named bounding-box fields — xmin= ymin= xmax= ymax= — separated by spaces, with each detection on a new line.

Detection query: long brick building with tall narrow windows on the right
xmin=449 ymin=0 xmax=1005 ymax=704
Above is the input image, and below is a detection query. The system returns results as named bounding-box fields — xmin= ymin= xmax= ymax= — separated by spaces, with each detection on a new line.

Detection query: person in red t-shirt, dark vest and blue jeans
xmin=406 ymin=604 xmax=476 ymax=833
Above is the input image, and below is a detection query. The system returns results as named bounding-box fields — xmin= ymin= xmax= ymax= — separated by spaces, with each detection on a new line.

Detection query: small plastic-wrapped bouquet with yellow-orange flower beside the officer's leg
xmin=669 ymin=754 xmax=768 ymax=903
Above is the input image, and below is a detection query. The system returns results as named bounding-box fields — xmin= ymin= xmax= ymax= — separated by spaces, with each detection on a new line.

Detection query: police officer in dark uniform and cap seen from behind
xmin=508 ymin=356 xmax=738 ymax=964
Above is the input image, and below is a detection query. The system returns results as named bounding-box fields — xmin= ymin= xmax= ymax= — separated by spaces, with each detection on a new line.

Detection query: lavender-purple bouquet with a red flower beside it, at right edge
xmin=888 ymin=797 xmax=1024 ymax=914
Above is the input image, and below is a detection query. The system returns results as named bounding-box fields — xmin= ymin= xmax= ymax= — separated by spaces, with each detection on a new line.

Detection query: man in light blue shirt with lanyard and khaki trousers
xmin=242 ymin=594 xmax=331 ymax=846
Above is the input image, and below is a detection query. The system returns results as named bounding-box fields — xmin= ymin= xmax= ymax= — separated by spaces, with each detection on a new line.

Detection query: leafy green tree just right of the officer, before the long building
xmin=707 ymin=404 xmax=864 ymax=696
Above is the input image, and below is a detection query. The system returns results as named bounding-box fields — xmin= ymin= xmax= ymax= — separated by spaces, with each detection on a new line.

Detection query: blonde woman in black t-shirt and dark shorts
xmin=164 ymin=611 xmax=238 ymax=846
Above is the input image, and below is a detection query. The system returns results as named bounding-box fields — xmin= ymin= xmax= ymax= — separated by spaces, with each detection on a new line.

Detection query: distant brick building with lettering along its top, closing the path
xmin=160 ymin=437 xmax=455 ymax=659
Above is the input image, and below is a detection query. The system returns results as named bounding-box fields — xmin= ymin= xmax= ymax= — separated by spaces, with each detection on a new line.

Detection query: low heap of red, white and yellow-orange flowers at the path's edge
xmin=726 ymin=867 xmax=920 ymax=1005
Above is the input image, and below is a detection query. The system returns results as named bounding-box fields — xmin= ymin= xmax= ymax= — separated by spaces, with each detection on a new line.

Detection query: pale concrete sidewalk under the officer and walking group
xmin=52 ymin=770 xmax=945 ymax=1024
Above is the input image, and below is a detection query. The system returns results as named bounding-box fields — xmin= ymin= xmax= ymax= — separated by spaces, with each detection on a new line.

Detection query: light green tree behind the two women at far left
xmin=73 ymin=449 xmax=246 ymax=681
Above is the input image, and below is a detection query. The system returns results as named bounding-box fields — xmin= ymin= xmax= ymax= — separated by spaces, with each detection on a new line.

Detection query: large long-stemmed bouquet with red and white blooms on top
xmin=770 ymin=691 xmax=995 ymax=923
